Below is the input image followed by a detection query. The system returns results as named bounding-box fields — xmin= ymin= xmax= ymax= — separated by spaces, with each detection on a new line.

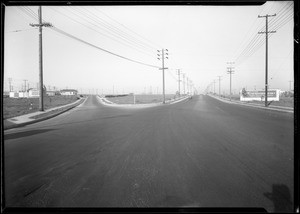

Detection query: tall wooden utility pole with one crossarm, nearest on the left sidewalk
xmin=29 ymin=6 xmax=52 ymax=111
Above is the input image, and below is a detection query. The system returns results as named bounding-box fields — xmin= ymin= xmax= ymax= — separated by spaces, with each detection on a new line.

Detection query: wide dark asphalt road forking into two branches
xmin=4 ymin=95 xmax=294 ymax=212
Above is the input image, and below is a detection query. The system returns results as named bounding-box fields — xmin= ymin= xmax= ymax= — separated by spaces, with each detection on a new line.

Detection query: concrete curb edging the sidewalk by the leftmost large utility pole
xmin=3 ymin=98 xmax=86 ymax=130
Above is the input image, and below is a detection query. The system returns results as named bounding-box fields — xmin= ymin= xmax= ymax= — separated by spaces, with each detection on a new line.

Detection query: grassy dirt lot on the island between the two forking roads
xmin=106 ymin=94 xmax=175 ymax=104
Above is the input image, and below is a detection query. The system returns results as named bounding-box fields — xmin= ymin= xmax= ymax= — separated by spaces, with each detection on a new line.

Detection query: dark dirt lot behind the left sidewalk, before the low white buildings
xmin=3 ymin=95 xmax=79 ymax=119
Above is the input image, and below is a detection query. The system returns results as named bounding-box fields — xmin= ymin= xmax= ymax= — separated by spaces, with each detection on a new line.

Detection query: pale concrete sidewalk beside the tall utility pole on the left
xmin=3 ymin=98 xmax=86 ymax=130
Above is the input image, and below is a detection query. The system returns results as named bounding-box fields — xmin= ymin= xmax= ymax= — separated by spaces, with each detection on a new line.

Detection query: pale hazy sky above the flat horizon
xmin=4 ymin=1 xmax=294 ymax=93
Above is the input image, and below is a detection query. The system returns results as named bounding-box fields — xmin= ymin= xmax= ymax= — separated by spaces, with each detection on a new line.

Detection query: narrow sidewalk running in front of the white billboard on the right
xmin=208 ymin=94 xmax=294 ymax=113
